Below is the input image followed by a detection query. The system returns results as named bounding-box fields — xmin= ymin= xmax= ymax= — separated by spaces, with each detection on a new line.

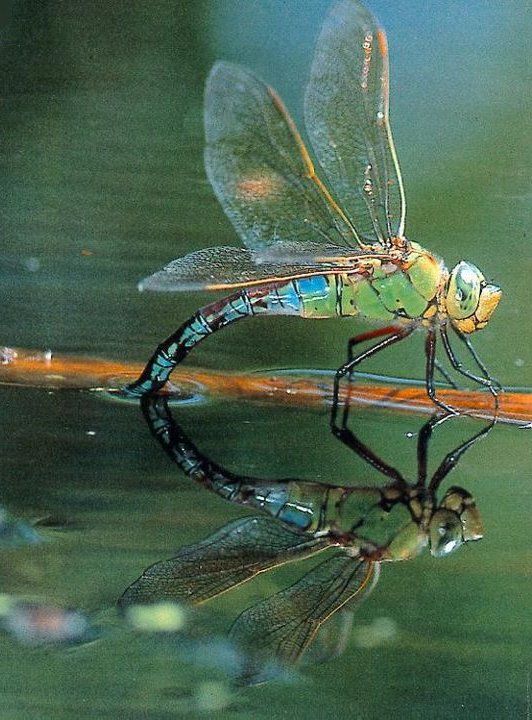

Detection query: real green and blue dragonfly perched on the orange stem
xmin=125 ymin=0 xmax=501 ymax=411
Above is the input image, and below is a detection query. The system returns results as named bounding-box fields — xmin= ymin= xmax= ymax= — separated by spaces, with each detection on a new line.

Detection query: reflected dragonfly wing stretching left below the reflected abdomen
xmin=120 ymin=517 xmax=333 ymax=606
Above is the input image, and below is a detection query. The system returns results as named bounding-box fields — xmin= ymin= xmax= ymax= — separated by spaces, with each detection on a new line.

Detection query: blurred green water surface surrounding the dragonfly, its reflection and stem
xmin=0 ymin=0 xmax=532 ymax=720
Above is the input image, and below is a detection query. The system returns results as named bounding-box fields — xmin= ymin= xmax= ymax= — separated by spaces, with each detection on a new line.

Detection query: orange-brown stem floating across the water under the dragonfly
xmin=0 ymin=348 xmax=532 ymax=425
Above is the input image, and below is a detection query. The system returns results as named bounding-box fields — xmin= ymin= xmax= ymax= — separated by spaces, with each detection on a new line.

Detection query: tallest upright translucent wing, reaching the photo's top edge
xmin=305 ymin=0 xmax=406 ymax=244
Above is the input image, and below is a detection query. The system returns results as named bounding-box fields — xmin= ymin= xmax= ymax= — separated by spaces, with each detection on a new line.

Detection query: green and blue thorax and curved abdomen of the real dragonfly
xmin=125 ymin=252 xmax=444 ymax=396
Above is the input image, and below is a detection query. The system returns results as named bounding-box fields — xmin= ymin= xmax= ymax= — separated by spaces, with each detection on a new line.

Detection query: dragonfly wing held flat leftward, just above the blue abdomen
xmin=139 ymin=242 xmax=378 ymax=292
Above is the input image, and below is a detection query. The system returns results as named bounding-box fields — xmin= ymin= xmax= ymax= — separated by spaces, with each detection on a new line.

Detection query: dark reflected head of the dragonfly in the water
xmin=429 ymin=487 xmax=484 ymax=557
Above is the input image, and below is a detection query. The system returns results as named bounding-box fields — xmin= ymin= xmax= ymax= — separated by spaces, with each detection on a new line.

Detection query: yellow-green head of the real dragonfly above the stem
xmin=445 ymin=260 xmax=502 ymax=333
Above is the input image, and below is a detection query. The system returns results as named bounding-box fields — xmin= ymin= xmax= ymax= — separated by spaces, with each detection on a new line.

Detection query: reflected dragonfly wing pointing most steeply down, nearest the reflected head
xmin=231 ymin=554 xmax=379 ymax=663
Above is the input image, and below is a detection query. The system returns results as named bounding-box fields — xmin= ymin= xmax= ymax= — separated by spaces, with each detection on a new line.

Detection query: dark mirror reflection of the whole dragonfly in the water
xmin=119 ymin=396 xmax=493 ymax=682
